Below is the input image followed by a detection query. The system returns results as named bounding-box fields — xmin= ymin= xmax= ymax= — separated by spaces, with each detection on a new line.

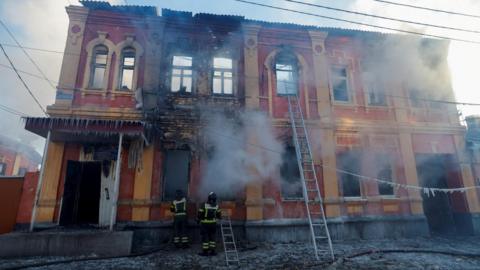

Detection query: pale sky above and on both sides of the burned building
xmin=0 ymin=0 xmax=480 ymax=153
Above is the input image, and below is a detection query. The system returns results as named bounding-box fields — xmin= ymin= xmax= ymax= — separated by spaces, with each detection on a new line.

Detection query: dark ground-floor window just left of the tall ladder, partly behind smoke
xmin=280 ymin=146 xmax=303 ymax=200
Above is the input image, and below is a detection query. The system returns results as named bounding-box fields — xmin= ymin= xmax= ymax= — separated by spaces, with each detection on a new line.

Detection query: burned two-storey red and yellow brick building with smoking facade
xmin=21 ymin=1 xmax=480 ymax=240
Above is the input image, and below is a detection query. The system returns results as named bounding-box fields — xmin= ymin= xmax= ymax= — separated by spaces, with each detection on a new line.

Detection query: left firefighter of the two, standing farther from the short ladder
xmin=170 ymin=190 xmax=188 ymax=248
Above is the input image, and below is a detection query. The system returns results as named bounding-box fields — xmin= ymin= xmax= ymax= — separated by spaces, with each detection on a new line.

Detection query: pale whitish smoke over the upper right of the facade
xmin=362 ymin=33 xmax=452 ymax=99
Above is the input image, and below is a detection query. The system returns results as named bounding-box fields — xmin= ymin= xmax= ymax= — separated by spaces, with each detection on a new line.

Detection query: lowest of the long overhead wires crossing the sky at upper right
xmin=233 ymin=0 xmax=480 ymax=44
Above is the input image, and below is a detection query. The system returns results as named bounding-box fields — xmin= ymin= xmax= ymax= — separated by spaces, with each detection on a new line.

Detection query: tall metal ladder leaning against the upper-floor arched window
xmin=287 ymin=94 xmax=335 ymax=261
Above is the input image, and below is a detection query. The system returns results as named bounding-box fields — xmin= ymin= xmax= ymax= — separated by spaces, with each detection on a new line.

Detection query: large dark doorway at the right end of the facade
xmin=416 ymin=154 xmax=471 ymax=235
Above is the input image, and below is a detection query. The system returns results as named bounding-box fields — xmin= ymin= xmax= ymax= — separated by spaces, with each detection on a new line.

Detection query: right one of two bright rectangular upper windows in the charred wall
xmin=212 ymin=57 xmax=233 ymax=95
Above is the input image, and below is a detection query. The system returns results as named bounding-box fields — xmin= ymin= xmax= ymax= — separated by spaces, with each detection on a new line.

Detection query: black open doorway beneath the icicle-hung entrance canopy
xmin=60 ymin=161 xmax=101 ymax=226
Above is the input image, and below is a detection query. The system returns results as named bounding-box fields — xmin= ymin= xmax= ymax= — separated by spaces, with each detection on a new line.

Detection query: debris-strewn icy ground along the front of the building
xmin=0 ymin=236 xmax=480 ymax=270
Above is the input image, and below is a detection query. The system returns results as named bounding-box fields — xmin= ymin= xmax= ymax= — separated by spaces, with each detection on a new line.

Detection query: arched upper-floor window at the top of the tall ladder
xmin=275 ymin=52 xmax=298 ymax=95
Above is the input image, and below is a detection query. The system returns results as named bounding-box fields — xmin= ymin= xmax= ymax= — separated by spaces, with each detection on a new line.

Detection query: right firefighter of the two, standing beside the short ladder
xmin=197 ymin=192 xmax=221 ymax=256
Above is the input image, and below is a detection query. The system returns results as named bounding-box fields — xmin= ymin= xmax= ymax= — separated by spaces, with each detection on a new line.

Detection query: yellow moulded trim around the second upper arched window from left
xmin=112 ymin=34 xmax=144 ymax=93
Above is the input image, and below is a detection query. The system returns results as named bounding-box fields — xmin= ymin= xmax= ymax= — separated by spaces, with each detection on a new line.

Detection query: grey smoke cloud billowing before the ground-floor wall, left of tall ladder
xmin=199 ymin=111 xmax=283 ymax=198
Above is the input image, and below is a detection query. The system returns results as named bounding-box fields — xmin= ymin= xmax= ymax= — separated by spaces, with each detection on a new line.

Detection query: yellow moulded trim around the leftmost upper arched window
xmin=82 ymin=31 xmax=115 ymax=91
